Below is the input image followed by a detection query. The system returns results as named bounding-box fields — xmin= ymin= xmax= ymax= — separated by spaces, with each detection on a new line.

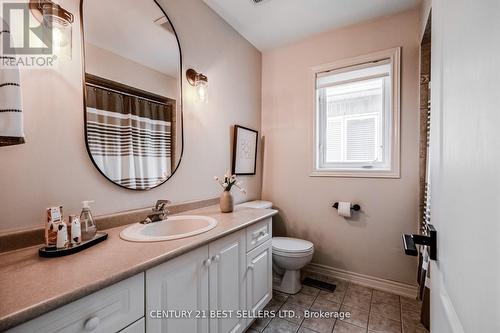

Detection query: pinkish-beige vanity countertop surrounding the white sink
xmin=0 ymin=206 xmax=277 ymax=331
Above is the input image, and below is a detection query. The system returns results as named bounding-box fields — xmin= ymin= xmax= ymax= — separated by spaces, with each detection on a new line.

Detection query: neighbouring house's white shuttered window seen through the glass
xmin=345 ymin=116 xmax=377 ymax=162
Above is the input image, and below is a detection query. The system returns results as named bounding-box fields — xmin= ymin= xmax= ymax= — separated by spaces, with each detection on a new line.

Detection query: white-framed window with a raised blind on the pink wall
xmin=312 ymin=48 xmax=399 ymax=177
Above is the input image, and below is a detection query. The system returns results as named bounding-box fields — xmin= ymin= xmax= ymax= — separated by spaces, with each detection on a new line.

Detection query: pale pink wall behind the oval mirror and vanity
xmin=0 ymin=0 xmax=261 ymax=232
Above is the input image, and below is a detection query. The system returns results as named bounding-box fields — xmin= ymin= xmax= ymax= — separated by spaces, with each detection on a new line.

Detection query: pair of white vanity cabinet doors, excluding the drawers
xmin=146 ymin=230 xmax=247 ymax=333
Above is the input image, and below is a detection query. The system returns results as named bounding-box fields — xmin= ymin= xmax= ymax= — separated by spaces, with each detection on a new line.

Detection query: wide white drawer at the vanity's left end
xmin=8 ymin=273 xmax=144 ymax=333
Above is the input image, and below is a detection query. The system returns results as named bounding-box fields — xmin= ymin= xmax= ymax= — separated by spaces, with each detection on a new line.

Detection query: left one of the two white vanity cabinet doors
xmin=146 ymin=246 xmax=209 ymax=333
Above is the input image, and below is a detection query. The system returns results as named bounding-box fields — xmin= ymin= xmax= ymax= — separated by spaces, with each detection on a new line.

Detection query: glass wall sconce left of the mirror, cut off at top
xmin=29 ymin=0 xmax=74 ymax=58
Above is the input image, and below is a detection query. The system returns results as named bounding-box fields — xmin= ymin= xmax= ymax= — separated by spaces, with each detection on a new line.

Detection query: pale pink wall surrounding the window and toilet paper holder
xmin=262 ymin=10 xmax=419 ymax=284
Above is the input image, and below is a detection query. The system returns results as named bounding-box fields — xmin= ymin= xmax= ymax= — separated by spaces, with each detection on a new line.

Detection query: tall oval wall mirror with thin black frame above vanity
xmin=80 ymin=0 xmax=183 ymax=190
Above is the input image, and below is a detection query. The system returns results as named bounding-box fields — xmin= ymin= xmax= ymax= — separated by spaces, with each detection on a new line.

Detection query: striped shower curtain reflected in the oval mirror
xmin=86 ymin=85 xmax=173 ymax=189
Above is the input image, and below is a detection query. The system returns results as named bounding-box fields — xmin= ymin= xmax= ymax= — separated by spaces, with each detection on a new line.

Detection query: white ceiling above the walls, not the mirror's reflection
xmin=203 ymin=0 xmax=421 ymax=51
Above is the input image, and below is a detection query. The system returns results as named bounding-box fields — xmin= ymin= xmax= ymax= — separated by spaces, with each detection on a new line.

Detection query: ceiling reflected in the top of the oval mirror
xmin=83 ymin=0 xmax=180 ymax=78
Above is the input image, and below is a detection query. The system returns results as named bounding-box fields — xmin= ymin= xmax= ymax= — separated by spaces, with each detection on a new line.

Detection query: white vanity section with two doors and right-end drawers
xmin=146 ymin=219 xmax=272 ymax=333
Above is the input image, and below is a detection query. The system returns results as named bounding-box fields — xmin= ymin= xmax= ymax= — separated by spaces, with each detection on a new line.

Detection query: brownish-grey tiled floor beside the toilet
xmin=247 ymin=276 xmax=428 ymax=333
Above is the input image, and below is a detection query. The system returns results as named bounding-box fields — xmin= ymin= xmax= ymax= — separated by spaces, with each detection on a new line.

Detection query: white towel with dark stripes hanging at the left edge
xmin=0 ymin=20 xmax=24 ymax=146
